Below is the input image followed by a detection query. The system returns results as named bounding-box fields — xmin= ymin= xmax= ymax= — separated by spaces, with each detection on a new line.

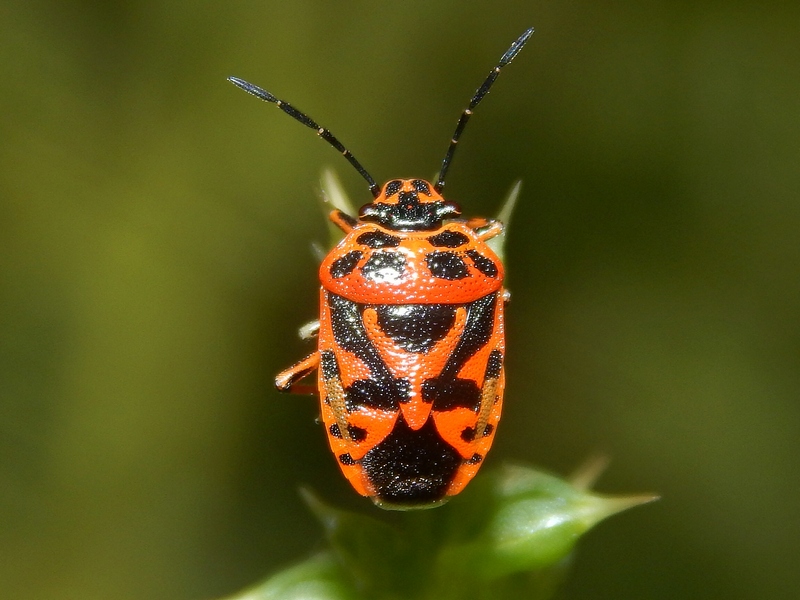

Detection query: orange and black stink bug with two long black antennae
xmin=230 ymin=29 xmax=533 ymax=509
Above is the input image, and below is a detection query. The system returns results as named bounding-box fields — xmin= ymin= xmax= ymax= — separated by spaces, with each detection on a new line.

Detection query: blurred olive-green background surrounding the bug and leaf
xmin=0 ymin=0 xmax=800 ymax=600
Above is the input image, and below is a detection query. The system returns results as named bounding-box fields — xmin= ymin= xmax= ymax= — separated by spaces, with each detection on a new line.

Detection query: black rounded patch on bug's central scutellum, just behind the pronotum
xmin=375 ymin=304 xmax=458 ymax=353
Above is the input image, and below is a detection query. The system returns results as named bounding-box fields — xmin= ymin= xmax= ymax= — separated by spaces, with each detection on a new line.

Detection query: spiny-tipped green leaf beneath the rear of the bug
xmin=220 ymin=461 xmax=655 ymax=600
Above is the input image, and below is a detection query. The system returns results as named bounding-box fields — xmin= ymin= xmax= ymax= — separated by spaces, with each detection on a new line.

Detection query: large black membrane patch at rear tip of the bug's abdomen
xmin=361 ymin=414 xmax=462 ymax=505
